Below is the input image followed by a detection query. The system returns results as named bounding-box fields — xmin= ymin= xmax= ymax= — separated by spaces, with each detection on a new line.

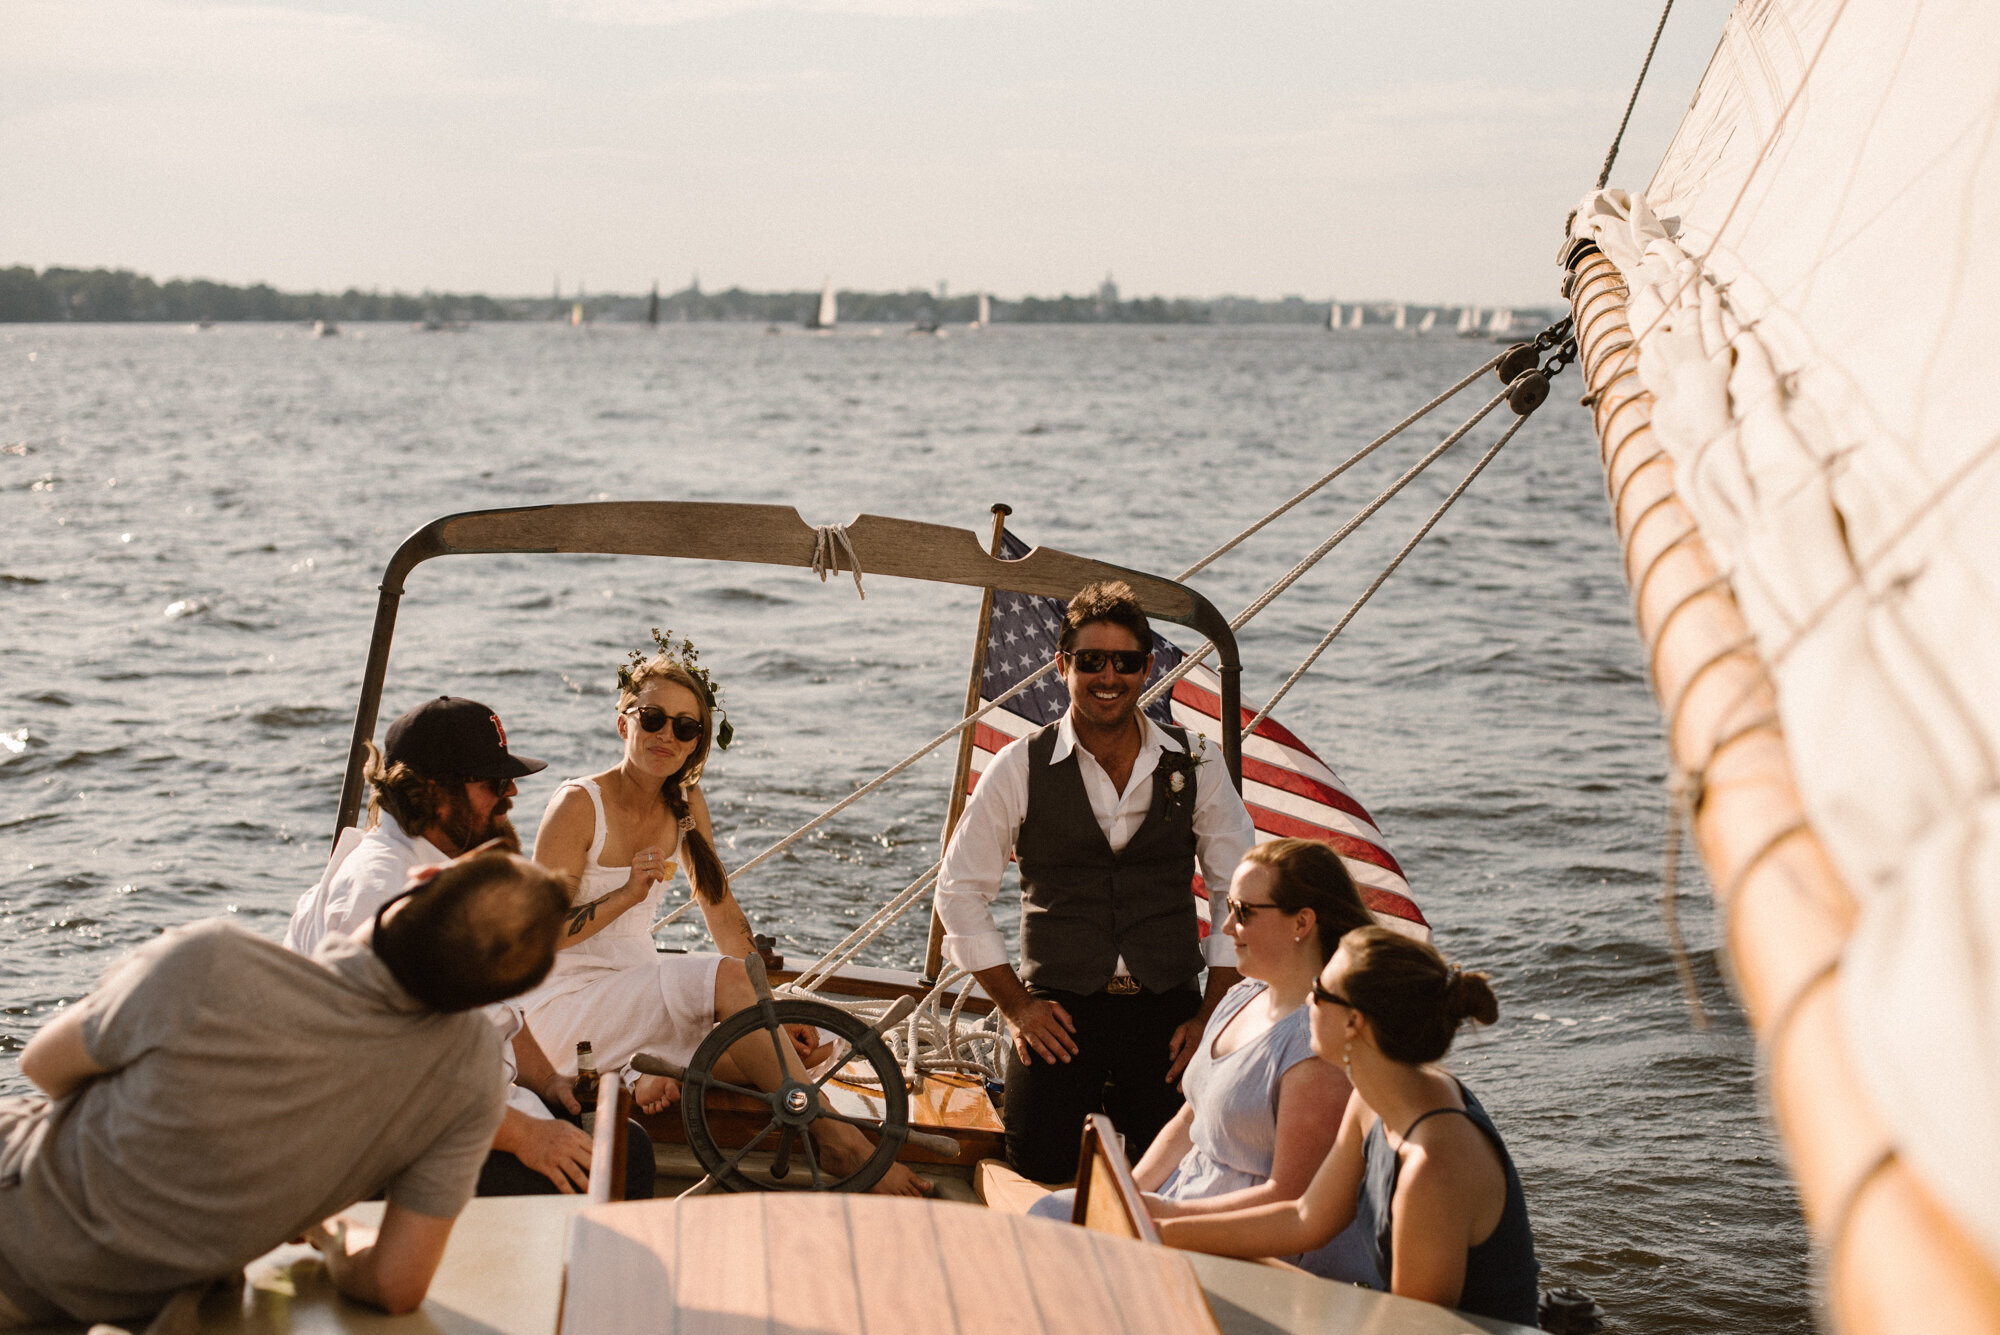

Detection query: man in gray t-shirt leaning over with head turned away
xmin=0 ymin=853 xmax=568 ymax=1325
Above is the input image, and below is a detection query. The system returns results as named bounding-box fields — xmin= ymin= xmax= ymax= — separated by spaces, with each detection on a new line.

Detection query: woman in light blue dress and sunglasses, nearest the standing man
xmin=1032 ymin=839 xmax=1382 ymax=1289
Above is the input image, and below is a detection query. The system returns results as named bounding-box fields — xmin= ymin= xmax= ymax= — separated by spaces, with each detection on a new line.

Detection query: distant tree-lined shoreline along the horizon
xmin=0 ymin=266 xmax=1536 ymax=332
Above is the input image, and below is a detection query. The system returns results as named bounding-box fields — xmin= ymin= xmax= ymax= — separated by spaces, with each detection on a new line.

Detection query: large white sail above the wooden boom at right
xmin=1574 ymin=0 xmax=2000 ymax=1271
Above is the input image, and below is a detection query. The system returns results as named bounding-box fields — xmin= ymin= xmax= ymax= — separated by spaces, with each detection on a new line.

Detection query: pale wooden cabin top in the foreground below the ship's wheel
xmin=19 ymin=1193 xmax=1532 ymax=1335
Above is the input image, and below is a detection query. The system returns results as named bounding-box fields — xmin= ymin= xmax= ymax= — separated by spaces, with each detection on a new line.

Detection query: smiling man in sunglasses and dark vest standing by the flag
xmin=938 ymin=584 xmax=1256 ymax=1181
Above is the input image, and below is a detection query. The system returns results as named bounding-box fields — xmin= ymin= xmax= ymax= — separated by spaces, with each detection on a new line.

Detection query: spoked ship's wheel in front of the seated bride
xmin=632 ymin=955 xmax=910 ymax=1191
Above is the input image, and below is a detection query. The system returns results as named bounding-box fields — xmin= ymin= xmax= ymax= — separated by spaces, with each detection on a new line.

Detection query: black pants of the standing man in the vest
xmin=1000 ymin=983 xmax=1202 ymax=1181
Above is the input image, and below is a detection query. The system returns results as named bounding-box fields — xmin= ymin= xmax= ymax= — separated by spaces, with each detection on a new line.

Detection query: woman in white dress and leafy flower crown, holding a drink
xmin=522 ymin=652 xmax=924 ymax=1195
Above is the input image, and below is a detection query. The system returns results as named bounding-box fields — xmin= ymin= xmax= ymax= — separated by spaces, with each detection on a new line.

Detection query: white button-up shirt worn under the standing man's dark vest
xmin=938 ymin=713 xmax=1256 ymax=973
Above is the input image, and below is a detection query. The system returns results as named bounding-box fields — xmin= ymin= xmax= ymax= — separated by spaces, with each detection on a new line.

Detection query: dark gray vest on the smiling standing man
xmin=1014 ymin=723 xmax=1202 ymax=993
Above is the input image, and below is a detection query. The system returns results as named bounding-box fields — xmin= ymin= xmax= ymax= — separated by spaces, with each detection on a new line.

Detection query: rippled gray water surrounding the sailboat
xmin=0 ymin=326 xmax=1810 ymax=1333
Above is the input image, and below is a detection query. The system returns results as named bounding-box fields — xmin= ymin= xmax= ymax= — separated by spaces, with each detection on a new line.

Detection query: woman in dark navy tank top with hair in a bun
xmin=1160 ymin=927 xmax=1540 ymax=1325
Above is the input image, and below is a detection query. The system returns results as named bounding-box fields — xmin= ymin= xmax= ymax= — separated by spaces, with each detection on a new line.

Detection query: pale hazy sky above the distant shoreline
xmin=0 ymin=0 xmax=1728 ymax=306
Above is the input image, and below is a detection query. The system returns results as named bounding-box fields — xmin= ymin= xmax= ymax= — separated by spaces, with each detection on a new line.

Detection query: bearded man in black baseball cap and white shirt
xmin=284 ymin=695 xmax=652 ymax=1199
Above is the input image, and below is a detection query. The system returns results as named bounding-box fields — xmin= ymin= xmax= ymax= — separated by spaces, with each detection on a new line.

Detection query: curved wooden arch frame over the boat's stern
xmin=334 ymin=502 xmax=1242 ymax=839
